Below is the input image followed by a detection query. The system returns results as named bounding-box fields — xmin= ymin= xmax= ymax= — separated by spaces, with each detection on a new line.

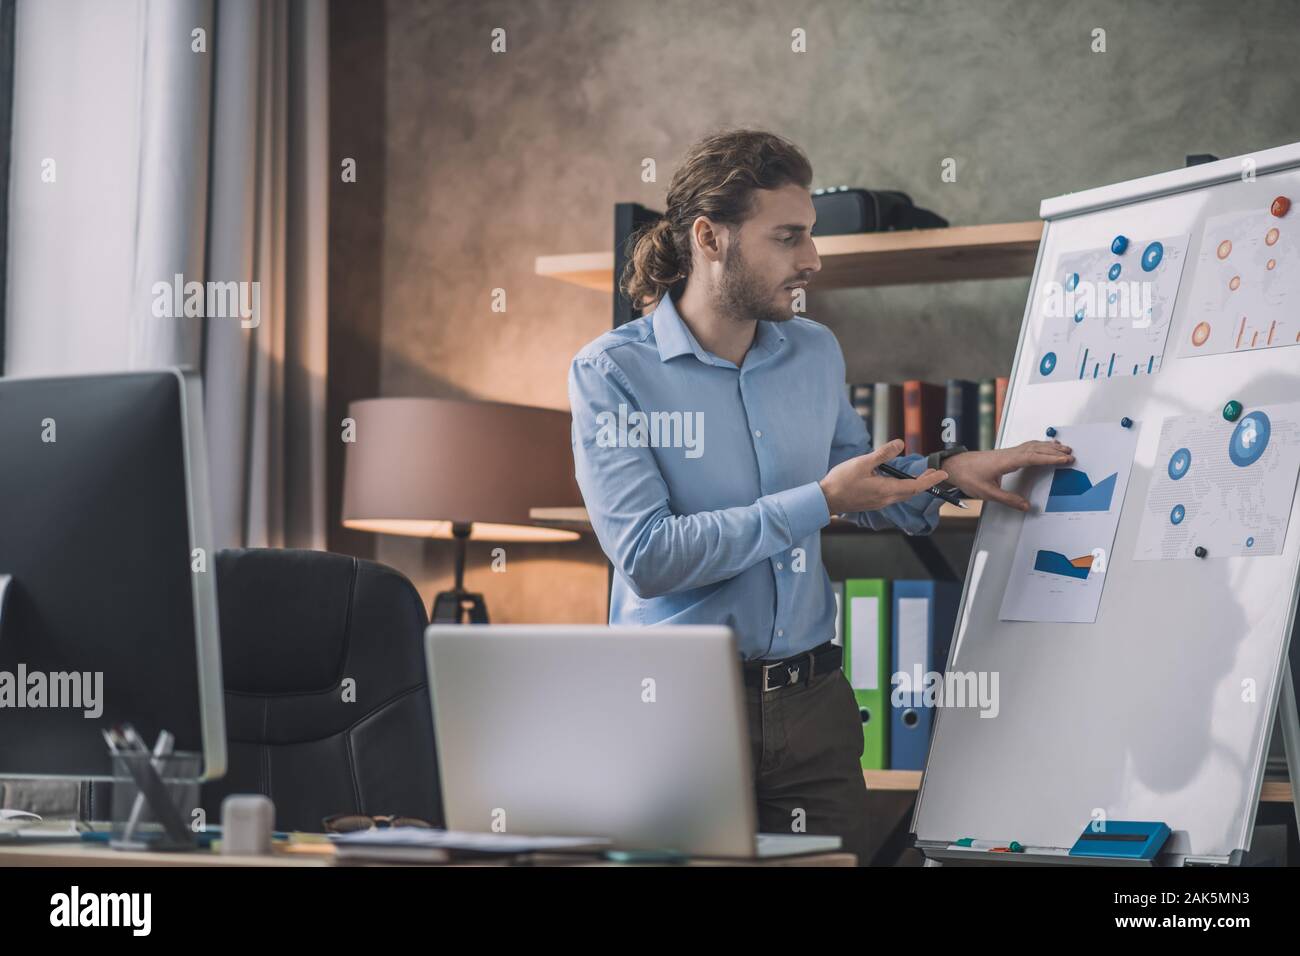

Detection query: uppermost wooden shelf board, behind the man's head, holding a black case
xmin=534 ymin=220 xmax=1043 ymax=293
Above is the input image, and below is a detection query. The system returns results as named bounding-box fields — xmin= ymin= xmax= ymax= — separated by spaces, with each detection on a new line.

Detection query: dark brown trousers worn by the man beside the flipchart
xmin=745 ymin=667 xmax=870 ymax=866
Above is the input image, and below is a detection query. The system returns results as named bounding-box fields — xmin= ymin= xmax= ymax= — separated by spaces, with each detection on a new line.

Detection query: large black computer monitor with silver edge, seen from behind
xmin=0 ymin=369 xmax=226 ymax=779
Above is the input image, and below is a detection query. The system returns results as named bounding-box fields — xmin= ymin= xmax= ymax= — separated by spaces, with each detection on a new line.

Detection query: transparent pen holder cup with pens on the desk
xmin=111 ymin=750 xmax=203 ymax=849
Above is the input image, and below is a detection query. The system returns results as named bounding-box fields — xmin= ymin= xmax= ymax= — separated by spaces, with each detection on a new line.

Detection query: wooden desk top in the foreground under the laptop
xmin=0 ymin=843 xmax=857 ymax=868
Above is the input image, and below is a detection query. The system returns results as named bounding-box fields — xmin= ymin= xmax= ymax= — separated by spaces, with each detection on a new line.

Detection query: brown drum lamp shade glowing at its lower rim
xmin=343 ymin=398 xmax=582 ymax=541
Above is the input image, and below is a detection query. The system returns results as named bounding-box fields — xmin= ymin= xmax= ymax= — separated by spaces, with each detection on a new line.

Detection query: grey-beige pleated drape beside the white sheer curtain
xmin=203 ymin=0 xmax=329 ymax=549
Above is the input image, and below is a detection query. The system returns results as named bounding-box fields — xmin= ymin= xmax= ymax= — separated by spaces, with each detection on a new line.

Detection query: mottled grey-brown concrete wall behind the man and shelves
xmin=330 ymin=0 xmax=1300 ymax=620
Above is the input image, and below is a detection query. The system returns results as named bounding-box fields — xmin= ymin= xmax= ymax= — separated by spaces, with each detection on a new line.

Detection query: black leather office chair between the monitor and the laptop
xmin=87 ymin=549 xmax=443 ymax=831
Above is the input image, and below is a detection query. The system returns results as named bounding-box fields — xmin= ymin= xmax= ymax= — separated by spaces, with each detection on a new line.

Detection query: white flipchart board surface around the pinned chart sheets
xmin=913 ymin=144 xmax=1300 ymax=861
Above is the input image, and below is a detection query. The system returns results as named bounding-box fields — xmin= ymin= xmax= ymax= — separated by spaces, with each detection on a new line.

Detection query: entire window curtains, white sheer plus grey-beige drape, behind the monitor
xmin=4 ymin=0 xmax=329 ymax=549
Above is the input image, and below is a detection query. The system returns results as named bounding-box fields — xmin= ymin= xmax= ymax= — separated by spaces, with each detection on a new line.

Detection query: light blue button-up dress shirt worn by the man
xmin=568 ymin=295 xmax=941 ymax=659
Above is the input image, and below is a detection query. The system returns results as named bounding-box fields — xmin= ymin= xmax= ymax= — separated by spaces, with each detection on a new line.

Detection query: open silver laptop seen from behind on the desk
xmin=425 ymin=624 xmax=840 ymax=858
